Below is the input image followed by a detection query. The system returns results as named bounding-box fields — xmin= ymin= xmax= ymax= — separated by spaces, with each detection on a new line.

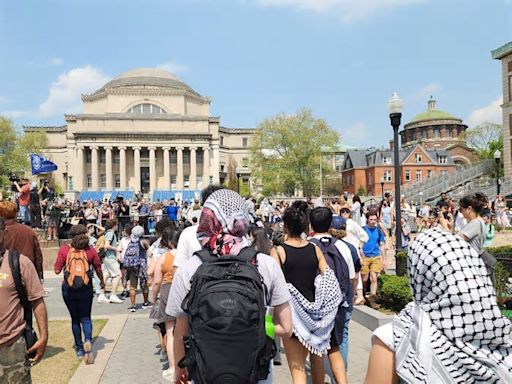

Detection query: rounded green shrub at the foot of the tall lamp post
xmin=377 ymin=275 xmax=412 ymax=312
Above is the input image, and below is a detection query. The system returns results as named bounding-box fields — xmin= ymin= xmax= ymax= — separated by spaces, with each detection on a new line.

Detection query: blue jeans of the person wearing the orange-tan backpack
xmin=62 ymin=283 xmax=93 ymax=351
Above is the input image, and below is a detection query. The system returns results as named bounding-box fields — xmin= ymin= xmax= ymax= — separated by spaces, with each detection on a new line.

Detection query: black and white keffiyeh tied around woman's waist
xmin=287 ymin=267 xmax=345 ymax=356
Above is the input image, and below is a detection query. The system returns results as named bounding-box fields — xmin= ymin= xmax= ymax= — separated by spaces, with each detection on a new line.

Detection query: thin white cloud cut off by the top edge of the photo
xmin=259 ymin=0 xmax=428 ymax=22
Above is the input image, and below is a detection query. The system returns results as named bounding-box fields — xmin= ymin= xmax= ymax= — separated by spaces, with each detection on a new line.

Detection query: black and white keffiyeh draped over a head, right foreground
xmin=393 ymin=229 xmax=512 ymax=384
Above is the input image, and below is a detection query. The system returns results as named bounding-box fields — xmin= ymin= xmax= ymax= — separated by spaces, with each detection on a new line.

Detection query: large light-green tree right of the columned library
xmin=251 ymin=108 xmax=339 ymax=196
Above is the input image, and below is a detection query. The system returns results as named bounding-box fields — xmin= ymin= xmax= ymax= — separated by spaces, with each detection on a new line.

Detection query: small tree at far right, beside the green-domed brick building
xmin=466 ymin=121 xmax=503 ymax=159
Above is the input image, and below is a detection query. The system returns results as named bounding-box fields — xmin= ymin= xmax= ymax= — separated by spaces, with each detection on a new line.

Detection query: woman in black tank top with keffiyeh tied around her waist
xmin=272 ymin=206 xmax=341 ymax=384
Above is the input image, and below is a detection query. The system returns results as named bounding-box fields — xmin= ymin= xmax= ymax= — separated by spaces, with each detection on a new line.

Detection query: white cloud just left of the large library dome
xmin=0 ymin=65 xmax=110 ymax=119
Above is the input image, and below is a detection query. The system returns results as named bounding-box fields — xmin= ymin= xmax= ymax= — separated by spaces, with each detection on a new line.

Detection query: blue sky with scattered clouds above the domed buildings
xmin=0 ymin=0 xmax=512 ymax=147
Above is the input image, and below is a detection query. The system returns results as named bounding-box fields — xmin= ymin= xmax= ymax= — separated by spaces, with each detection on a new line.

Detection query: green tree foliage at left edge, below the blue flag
xmin=0 ymin=116 xmax=47 ymax=185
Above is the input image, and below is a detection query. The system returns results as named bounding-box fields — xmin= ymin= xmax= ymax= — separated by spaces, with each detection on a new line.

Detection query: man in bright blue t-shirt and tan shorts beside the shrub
xmin=361 ymin=212 xmax=387 ymax=306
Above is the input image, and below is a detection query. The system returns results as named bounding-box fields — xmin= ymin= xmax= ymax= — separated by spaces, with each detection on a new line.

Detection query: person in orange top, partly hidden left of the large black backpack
xmin=152 ymin=226 xmax=180 ymax=380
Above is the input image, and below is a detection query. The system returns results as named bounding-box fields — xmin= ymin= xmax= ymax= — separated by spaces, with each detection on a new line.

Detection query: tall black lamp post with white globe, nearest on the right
xmin=388 ymin=92 xmax=404 ymax=252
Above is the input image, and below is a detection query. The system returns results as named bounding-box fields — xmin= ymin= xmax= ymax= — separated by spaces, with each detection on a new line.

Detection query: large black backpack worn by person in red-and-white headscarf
xmin=179 ymin=248 xmax=276 ymax=384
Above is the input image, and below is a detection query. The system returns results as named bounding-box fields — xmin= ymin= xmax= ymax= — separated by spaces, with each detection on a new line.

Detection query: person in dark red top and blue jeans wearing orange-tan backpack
xmin=54 ymin=224 xmax=105 ymax=364
